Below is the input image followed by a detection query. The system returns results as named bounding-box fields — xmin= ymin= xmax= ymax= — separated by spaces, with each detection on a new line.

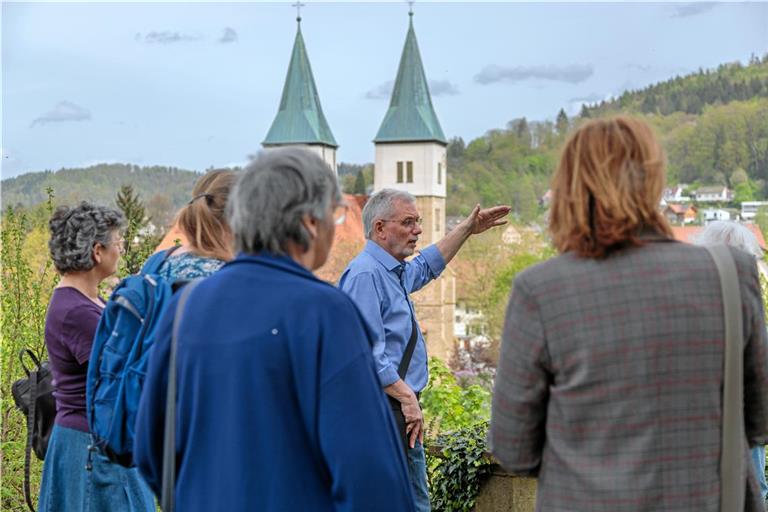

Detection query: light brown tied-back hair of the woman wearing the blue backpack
xmin=176 ymin=169 xmax=235 ymax=260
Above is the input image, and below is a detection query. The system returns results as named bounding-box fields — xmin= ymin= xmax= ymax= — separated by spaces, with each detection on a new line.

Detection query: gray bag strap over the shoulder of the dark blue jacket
xmin=160 ymin=279 xmax=201 ymax=512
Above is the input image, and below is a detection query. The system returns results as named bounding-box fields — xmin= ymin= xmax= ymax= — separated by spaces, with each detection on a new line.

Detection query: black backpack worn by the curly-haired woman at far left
xmin=11 ymin=348 xmax=56 ymax=512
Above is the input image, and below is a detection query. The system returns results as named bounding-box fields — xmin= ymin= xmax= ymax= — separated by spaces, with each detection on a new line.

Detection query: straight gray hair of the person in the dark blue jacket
xmin=227 ymin=148 xmax=341 ymax=255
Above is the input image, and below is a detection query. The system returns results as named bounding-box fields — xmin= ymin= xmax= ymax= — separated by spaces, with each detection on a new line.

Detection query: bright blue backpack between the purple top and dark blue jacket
xmin=85 ymin=247 xmax=179 ymax=467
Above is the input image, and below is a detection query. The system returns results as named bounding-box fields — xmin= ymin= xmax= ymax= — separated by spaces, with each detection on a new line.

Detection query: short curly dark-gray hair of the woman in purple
xmin=48 ymin=201 xmax=125 ymax=274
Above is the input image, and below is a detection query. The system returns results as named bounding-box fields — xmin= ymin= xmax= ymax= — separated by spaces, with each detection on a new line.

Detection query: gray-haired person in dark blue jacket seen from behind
xmin=135 ymin=149 xmax=413 ymax=511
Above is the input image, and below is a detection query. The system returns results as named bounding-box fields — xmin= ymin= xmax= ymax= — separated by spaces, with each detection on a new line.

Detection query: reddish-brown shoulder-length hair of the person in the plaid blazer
xmin=549 ymin=117 xmax=672 ymax=258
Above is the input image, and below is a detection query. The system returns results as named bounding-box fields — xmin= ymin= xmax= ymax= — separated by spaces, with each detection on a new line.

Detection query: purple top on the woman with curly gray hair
xmin=45 ymin=287 xmax=102 ymax=432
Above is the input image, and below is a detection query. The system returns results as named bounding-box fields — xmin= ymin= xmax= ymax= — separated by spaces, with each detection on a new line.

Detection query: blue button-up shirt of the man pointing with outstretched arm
xmin=339 ymin=240 xmax=445 ymax=392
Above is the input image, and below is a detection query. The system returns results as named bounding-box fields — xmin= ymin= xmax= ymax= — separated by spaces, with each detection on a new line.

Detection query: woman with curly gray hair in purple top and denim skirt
xmin=39 ymin=202 xmax=155 ymax=512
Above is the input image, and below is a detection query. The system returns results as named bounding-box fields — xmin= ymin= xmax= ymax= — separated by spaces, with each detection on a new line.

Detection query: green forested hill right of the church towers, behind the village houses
xmin=447 ymin=55 xmax=768 ymax=221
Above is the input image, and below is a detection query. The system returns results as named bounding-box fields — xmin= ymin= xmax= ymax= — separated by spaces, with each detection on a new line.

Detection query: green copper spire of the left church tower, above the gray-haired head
xmin=262 ymin=22 xmax=339 ymax=148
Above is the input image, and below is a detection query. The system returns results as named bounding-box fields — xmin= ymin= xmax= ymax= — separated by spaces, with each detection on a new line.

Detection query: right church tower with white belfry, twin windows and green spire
xmin=373 ymin=11 xmax=456 ymax=360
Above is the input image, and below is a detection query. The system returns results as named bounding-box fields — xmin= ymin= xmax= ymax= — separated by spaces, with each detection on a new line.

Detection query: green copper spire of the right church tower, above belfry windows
xmin=373 ymin=12 xmax=448 ymax=144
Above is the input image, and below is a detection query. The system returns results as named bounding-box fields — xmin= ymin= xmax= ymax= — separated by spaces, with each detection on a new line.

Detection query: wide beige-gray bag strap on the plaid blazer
xmin=707 ymin=245 xmax=746 ymax=512
